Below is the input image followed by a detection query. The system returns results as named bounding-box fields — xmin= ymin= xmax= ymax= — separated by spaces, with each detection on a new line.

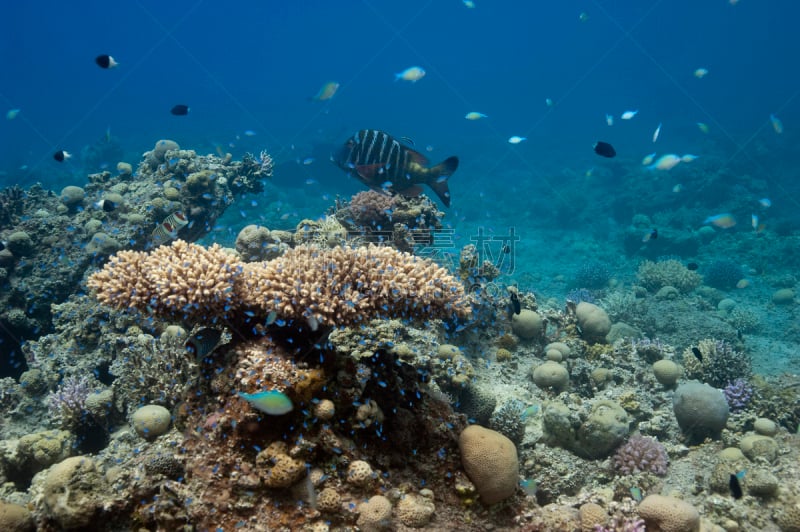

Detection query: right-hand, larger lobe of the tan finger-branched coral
xmin=238 ymin=246 xmax=469 ymax=325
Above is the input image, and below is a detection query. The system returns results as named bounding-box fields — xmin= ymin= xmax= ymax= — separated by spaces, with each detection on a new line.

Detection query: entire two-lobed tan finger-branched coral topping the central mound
xmin=88 ymin=240 xmax=470 ymax=328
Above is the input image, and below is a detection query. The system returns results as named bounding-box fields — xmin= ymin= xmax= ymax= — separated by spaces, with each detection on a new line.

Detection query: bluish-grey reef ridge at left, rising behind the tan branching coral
xmin=0 ymin=141 xmax=271 ymax=376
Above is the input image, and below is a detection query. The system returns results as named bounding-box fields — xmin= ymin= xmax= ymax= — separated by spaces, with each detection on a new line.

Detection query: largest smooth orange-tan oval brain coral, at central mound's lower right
xmin=458 ymin=425 xmax=519 ymax=504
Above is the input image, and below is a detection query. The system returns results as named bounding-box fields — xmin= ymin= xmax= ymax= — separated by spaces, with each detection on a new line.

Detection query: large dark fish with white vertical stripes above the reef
xmin=333 ymin=129 xmax=458 ymax=207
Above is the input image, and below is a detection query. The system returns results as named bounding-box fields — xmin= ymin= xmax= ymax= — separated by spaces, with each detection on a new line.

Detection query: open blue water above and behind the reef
xmin=0 ymin=0 xmax=800 ymax=243
